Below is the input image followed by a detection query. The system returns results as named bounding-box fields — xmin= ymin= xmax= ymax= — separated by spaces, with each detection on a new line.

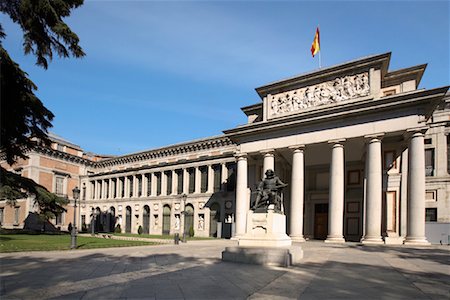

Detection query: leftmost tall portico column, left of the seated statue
xmin=235 ymin=154 xmax=250 ymax=237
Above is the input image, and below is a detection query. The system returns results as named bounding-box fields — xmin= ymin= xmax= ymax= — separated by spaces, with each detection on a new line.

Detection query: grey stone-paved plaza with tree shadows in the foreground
xmin=0 ymin=240 xmax=450 ymax=300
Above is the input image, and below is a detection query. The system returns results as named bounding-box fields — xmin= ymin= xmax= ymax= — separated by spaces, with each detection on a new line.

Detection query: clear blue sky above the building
xmin=0 ymin=1 xmax=450 ymax=155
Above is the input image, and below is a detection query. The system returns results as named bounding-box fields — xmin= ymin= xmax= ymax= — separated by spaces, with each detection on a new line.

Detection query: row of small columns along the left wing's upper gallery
xmin=90 ymin=163 xmax=228 ymax=199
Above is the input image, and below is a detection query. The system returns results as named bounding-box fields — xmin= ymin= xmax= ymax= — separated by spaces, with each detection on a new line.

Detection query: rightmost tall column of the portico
xmin=405 ymin=132 xmax=430 ymax=245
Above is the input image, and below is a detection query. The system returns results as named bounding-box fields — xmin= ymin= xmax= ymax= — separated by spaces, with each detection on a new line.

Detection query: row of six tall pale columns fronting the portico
xmin=236 ymin=132 xmax=428 ymax=244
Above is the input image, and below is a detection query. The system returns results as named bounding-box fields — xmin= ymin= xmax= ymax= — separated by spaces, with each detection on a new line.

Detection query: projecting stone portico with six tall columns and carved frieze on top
xmin=225 ymin=53 xmax=447 ymax=244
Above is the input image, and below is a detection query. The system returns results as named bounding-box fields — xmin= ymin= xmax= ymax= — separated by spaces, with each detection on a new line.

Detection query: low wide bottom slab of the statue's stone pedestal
xmin=222 ymin=247 xmax=303 ymax=267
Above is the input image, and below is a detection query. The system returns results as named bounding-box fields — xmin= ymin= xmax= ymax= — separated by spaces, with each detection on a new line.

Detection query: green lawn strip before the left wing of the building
xmin=0 ymin=234 xmax=156 ymax=252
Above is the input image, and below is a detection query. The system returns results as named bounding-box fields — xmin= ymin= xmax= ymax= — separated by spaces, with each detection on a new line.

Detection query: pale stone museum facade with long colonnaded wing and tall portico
xmin=0 ymin=53 xmax=450 ymax=244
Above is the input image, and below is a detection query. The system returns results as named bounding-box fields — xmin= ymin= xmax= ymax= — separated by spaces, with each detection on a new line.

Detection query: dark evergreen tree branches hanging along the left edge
xmin=0 ymin=0 xmax=85 ymax=225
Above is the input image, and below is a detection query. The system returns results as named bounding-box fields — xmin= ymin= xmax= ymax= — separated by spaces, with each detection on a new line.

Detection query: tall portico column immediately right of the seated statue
xmin=289 ymin=146 xmax=305 ymax=242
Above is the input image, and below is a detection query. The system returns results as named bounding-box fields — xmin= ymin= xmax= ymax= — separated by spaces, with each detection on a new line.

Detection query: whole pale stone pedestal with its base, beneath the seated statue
xmin=222 ymin=209 xmax=303 ymax=267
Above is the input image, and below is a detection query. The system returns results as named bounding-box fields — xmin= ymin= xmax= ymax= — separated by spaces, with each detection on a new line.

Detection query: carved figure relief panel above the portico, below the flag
xmin=269 ymin=72 xmax=370 ymax=117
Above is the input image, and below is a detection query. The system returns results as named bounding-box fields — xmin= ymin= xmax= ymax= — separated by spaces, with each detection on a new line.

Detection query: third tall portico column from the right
xmin=325 ymin=140 xmax=345 ymax=243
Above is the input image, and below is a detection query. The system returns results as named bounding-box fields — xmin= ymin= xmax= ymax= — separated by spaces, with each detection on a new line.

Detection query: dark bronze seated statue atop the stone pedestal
xmin=251 ymin=169 xmax=287 ymax=213
